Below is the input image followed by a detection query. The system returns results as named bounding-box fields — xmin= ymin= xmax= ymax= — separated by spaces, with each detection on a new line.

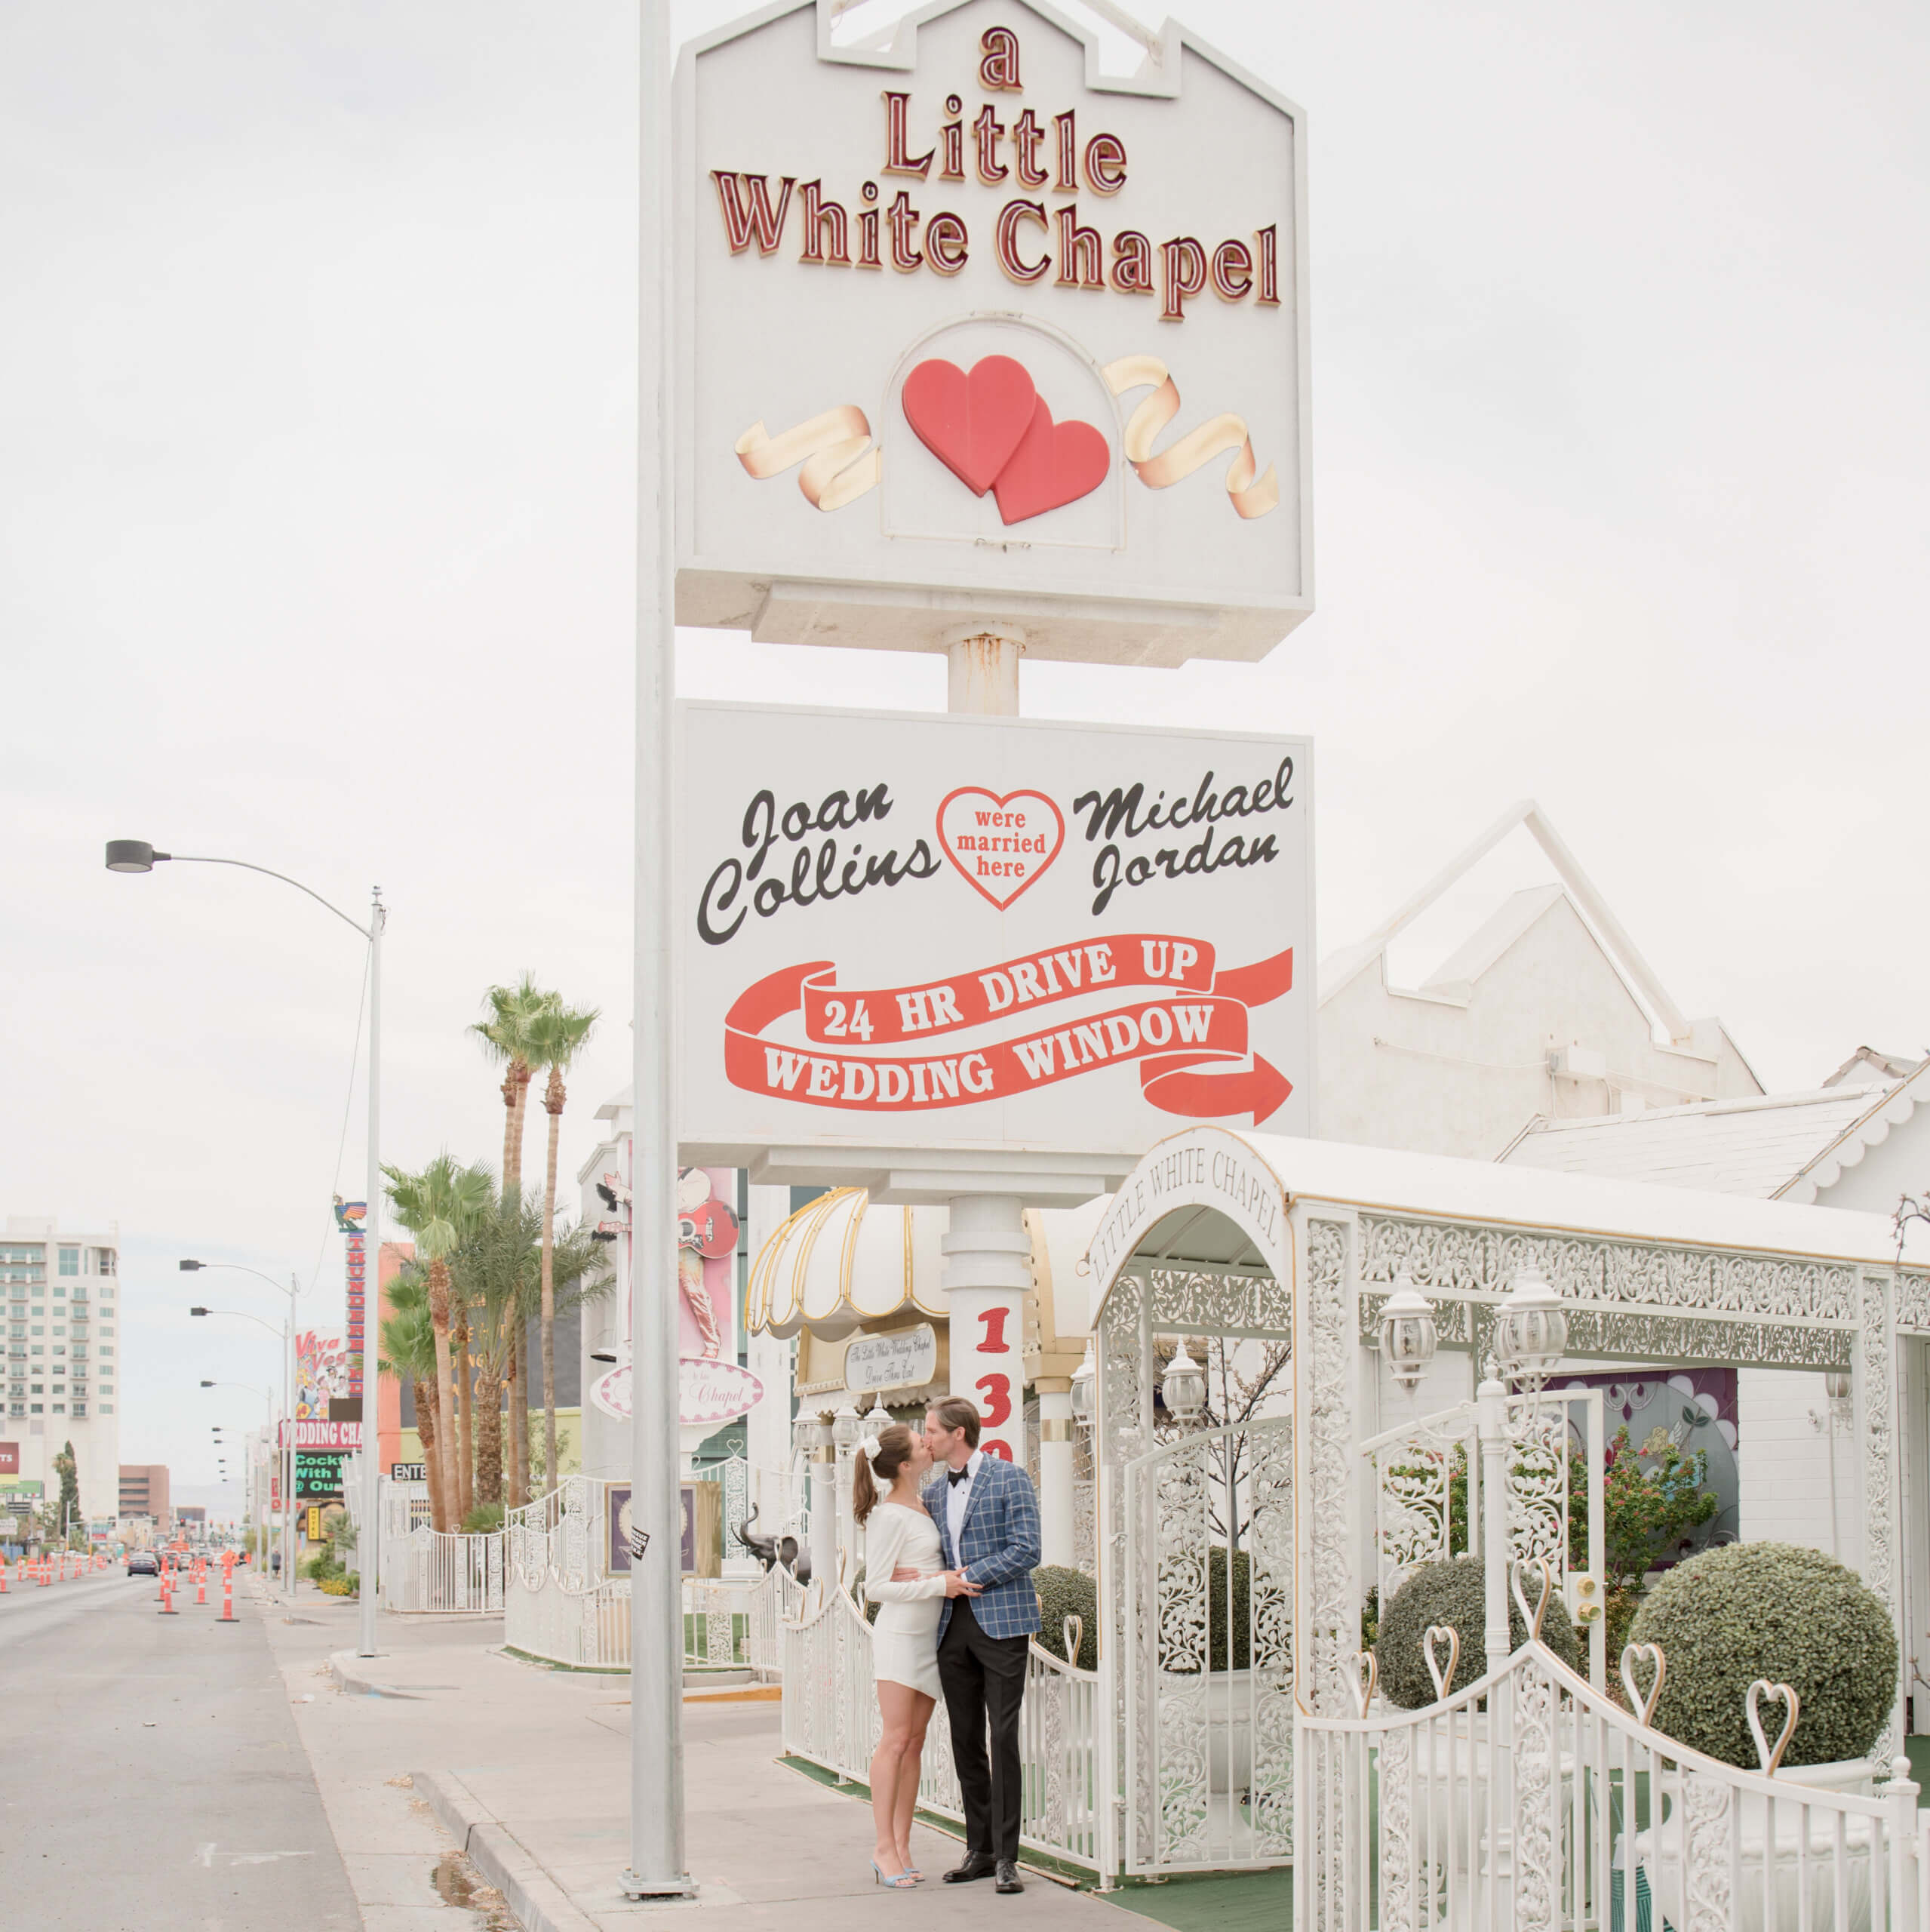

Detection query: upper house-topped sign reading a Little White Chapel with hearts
xmin=676 ymin=0 xmax=1312 ymax=665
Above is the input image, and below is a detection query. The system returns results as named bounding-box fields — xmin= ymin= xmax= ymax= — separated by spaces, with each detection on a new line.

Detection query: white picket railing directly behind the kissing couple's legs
xmin=782 ymin=1584 xmax=1099 ymax=1870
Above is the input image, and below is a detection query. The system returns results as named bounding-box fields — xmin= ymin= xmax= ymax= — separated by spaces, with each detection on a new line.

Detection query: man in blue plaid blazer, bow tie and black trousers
xmin=926 ymin=1395 xmax=1040 ymax=1891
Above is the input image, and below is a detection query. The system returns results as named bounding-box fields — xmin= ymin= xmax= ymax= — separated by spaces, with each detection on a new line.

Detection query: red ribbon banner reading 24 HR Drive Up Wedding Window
xmin=724 ymin=933 xmax=1292 ymax=1126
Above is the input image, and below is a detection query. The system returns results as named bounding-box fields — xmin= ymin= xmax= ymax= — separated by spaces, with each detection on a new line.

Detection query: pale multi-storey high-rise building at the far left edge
xmin=0 ymin=1215 xmax=121 ymax=1518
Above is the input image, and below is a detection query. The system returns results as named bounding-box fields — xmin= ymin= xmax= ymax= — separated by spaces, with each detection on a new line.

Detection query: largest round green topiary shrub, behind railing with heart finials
xmin=1629 ymin=1543 xmax=1897 ymax=1770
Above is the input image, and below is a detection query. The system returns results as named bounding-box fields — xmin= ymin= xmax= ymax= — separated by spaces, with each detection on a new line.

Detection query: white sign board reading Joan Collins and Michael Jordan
xmin=676 ymin=703 xmax=1314 ymax=1165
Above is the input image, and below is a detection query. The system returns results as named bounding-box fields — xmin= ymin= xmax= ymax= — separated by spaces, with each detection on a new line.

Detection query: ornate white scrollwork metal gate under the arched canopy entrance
xmin=1124 ymin=1416 xmax=1295 ymax=1874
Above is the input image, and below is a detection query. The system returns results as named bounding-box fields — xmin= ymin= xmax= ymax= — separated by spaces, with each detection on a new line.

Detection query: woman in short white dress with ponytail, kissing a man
xmin=852 ymin=1422 xmax=978 ymax=1886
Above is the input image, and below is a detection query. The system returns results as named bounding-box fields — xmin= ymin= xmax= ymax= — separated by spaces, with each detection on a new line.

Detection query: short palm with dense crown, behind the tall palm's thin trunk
xmin=450 ymin=1196 xmax=614 ymax=1503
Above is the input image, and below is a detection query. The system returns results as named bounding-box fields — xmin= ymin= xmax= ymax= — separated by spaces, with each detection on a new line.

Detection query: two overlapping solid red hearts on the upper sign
xmin=902 ymin=355 xmax=1113 ymax=524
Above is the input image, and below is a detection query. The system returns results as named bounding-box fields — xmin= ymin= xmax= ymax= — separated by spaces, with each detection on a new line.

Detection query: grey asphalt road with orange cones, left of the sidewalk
xmin=0 ymin=1567 xmax=363 ymax=1932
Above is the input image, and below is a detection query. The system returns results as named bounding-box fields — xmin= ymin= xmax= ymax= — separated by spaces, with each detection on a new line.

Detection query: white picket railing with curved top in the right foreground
xmin=1295 ymin=1638 xmax=1930 ymax=1932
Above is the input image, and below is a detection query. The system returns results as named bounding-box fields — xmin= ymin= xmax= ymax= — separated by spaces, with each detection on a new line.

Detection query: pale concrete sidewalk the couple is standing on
xmin=269 ymin=1600 xmax=1123 ymax=1932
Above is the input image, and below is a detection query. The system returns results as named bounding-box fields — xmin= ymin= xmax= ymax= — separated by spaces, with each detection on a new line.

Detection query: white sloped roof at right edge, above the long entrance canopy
xmin=1501 ymin=1069 xmax=1930 ymax=1201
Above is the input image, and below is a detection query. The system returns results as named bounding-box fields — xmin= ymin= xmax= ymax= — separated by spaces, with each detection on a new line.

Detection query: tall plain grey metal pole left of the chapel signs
xmin=622 ymin=0 xmax=696 ymax=1897
